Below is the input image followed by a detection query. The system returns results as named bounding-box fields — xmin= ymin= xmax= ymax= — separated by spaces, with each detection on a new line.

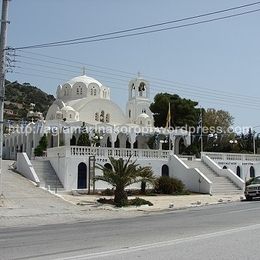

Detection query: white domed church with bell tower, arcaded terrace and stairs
xmin=4 ymin=75 xmax=254 ymax=194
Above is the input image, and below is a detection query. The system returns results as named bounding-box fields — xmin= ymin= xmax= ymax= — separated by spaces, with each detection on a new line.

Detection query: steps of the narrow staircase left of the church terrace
xmin=31 ymin=159 xmax=64 ymax=191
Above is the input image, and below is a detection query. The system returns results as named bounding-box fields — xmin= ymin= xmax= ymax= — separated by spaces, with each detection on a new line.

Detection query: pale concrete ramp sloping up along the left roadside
xmin=0 ymin=161 xmax=141 ymax=228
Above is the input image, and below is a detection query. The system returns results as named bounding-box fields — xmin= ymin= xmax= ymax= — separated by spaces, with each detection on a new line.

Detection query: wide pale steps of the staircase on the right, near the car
xmin=182 ymin=159 xmax=243 ymax=194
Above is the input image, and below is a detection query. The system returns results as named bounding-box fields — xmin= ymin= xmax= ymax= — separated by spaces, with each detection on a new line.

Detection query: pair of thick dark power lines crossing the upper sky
xmin=14 ymin=2 xmax=260 ymax=50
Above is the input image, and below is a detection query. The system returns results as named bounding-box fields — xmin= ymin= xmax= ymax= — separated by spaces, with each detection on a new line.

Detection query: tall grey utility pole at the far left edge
xmin=0 ymin=0 xmax=10 ymax=198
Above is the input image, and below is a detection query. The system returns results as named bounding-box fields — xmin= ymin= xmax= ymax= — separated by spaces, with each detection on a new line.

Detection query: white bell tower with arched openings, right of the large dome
xmin=126 ymin=73 xmax=153 ymax=126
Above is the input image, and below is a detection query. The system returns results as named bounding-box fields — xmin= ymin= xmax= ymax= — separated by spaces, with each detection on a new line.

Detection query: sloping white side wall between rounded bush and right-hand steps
xmin=168 ymin=154 xmax=212 ymax=194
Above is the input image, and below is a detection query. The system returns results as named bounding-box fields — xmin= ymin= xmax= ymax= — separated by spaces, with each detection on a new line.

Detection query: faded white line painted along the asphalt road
xmin=56 ymin=224 xmax=260 ymax=260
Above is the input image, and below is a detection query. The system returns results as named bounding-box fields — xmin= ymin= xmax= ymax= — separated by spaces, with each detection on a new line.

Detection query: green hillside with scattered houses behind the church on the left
xmin=4 ymin=81 xmax=55 ymax=121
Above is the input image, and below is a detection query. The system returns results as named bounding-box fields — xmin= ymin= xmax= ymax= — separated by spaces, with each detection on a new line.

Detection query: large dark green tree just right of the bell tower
xmin=150 ymin=93 xmax=199 ymax=127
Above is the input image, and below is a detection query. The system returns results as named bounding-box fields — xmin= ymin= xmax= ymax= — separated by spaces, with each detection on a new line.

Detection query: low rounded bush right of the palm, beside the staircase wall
xmin=155 ymin=176 xmax=185 ymax=194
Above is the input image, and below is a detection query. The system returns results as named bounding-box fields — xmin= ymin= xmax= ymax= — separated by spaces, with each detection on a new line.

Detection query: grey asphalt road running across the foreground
xmin=0 ymin=201 xmax=260 ymax=260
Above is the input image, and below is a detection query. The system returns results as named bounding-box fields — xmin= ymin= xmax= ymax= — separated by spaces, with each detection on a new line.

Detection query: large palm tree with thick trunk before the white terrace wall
xmin=95 ymin=156 xmax=155 ymax=207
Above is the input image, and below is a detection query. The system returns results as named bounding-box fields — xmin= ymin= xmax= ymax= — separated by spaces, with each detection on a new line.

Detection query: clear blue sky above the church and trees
xmin=7 ymin=0 xmax=260 ymax=126
